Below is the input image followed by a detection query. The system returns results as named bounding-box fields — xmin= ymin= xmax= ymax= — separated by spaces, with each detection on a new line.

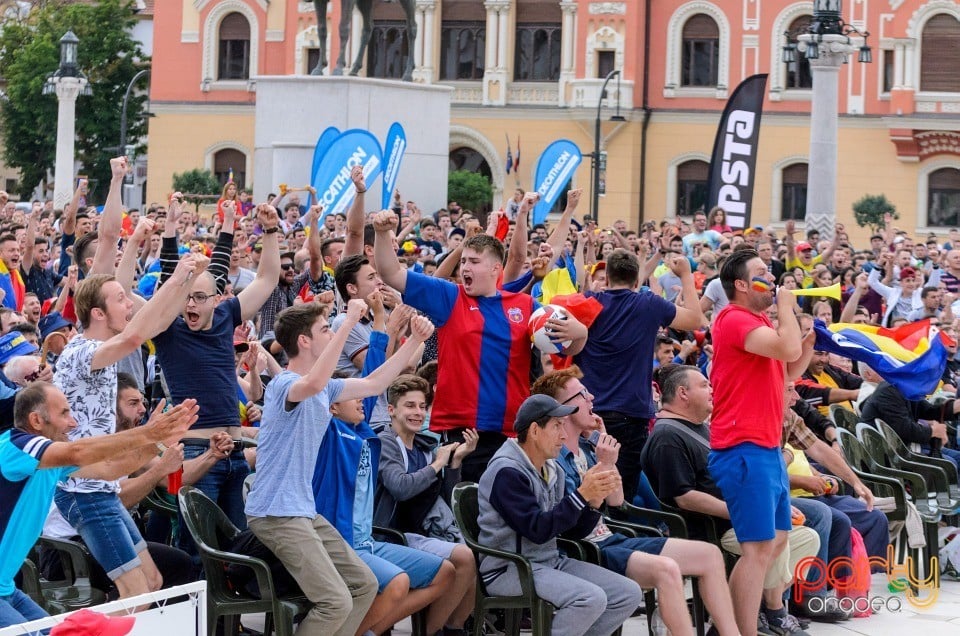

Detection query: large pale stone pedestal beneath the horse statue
xmin=253 ymin=75 xmax=452 ymax=214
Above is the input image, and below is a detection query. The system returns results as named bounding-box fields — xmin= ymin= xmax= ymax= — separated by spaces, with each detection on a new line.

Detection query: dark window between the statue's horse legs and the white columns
xmin=440 ymin=0 xmax=487 ymax=81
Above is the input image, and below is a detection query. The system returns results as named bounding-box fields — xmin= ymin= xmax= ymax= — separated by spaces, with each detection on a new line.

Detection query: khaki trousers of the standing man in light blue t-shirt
xmin=247 ymin=515 xmax=377 ymax=636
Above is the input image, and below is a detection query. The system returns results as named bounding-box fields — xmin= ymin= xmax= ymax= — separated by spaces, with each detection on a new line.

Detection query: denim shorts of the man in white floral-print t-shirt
xmin=54 ymin=490 xmax=147 ymax=581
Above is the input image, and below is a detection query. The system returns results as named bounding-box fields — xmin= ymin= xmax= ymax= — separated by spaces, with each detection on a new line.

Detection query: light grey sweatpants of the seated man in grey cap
xmin=487 ymin=557 xmax=643 ymax=636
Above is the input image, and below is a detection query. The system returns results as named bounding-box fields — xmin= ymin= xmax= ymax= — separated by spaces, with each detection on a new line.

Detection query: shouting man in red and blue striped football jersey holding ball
xmin=373 ymin=209 xmax=587 ymax=481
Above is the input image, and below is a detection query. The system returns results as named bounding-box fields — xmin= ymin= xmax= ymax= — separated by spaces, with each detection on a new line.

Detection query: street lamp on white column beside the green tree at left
xmin=42 ymin=31 xmax=93 ymax=209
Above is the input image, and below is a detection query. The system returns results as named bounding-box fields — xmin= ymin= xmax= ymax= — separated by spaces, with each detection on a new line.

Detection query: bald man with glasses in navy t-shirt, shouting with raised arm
xmin=153 ymin=204 xmax=282 ymax=553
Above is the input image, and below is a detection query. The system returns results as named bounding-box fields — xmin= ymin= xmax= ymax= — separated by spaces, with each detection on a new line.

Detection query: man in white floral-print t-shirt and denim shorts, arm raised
xmin=54 ymin=254 xmax=207 ymax=598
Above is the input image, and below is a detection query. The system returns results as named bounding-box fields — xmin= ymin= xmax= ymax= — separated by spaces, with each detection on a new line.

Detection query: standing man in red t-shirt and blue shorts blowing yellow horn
xmin=709 ymin=250 xmax=813 ymax=634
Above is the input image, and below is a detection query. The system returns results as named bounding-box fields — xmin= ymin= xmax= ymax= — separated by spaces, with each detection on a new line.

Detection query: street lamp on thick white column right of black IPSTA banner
xmin=782 ymin=0 xmax=873 ymax=239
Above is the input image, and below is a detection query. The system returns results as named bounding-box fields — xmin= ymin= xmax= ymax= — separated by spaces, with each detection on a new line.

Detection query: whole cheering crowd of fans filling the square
xmin=0 ymin=158 xmax=960 ymax=636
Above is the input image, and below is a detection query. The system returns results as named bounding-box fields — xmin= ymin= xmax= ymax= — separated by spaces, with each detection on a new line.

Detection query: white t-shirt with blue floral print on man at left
xmin=53 ymin=336 xmax=120 ymax=493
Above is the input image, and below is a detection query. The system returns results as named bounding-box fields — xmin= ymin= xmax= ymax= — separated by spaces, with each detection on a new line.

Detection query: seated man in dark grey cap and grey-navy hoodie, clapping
xmin=479 ymin=395 xmax=641 ymax=636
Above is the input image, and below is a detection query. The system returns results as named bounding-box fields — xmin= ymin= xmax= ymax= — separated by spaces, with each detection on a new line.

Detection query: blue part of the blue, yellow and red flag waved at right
xmin=813 ymin=320 xmax=947 ymax=400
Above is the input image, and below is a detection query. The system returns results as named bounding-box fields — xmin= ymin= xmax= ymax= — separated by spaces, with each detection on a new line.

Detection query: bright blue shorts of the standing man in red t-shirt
xmin=707 ymin=442 xmax=793 ymax=543
